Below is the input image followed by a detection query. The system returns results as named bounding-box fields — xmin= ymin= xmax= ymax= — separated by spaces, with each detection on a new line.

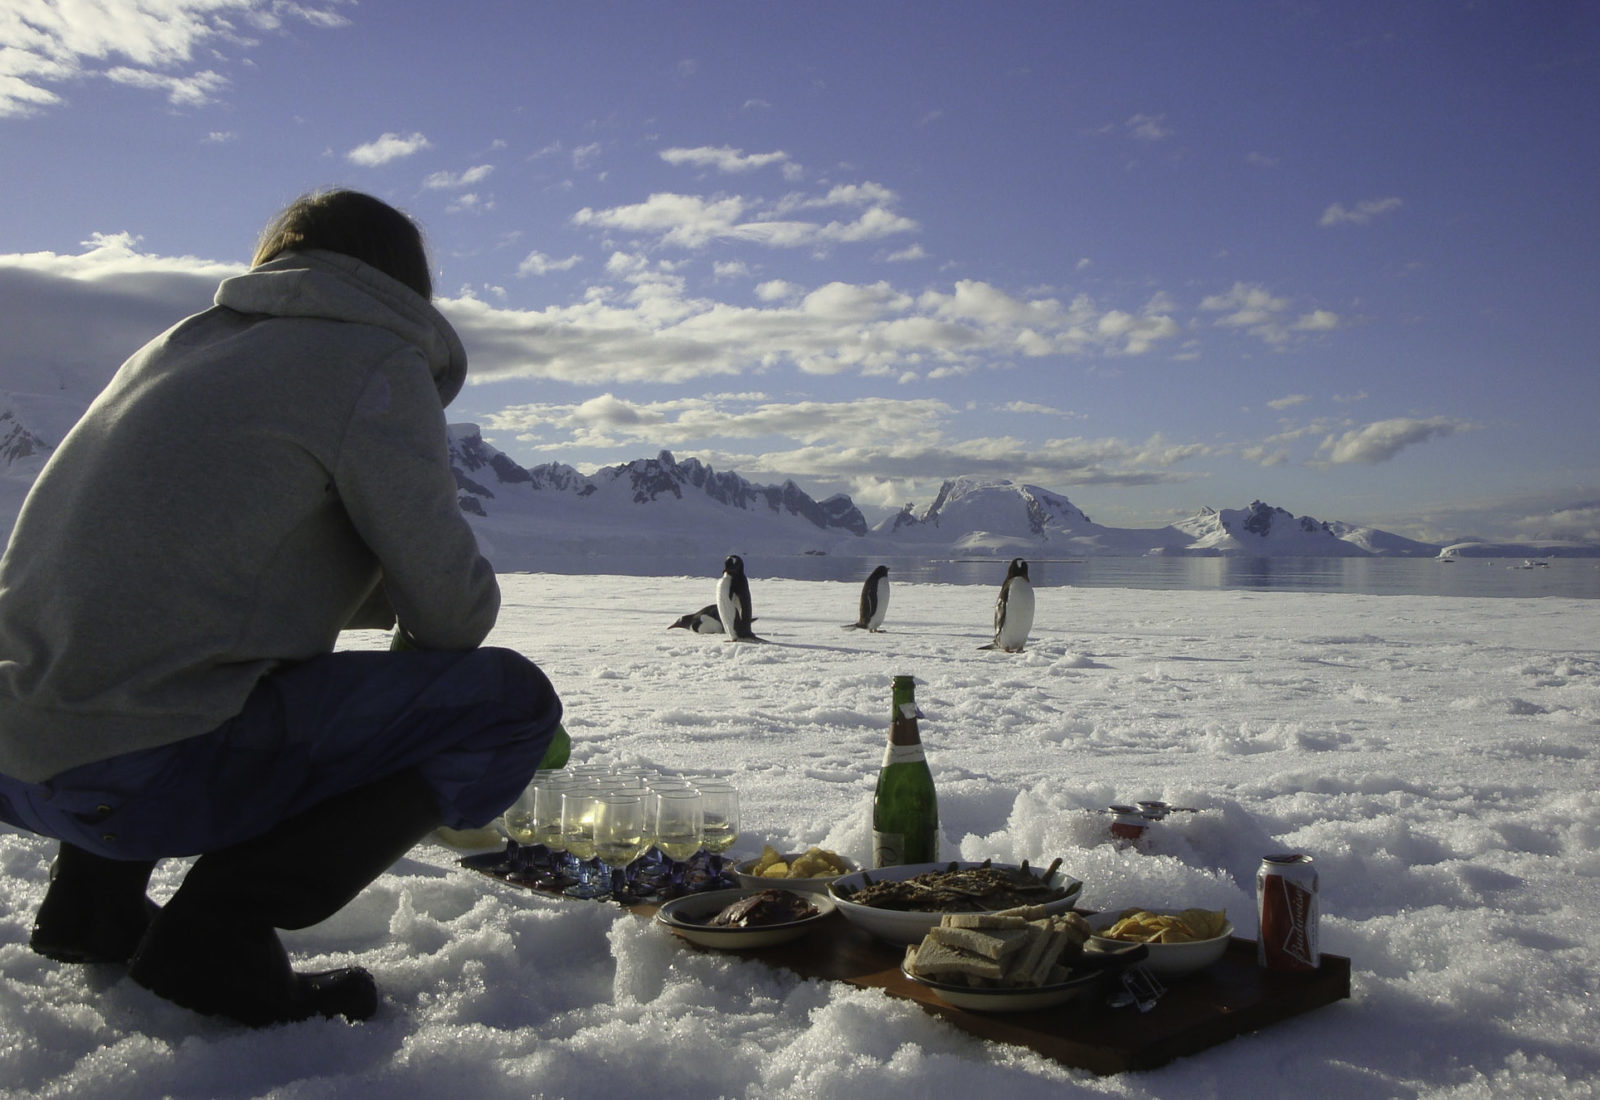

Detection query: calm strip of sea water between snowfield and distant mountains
xmin=518 ymin=555 xmax=1600 ymax=600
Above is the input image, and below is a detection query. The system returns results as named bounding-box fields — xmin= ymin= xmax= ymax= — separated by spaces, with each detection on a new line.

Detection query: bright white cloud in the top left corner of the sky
xmin=0 ymin=0 xmax=347 ymax=118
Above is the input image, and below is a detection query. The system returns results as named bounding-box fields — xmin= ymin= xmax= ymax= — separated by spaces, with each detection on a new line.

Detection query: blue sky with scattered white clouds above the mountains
xmin=0 ymin=0 xmax=1600 ymax=540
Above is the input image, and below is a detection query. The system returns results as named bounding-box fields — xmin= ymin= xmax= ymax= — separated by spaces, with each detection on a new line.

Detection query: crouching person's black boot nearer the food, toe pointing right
xmin=128 ymin=771 xmax=440 ymax=1026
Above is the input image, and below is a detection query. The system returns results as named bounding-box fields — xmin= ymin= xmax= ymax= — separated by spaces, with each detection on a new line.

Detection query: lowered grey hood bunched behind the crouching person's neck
xmin=216 ymin=249 xmax=467 ymax=405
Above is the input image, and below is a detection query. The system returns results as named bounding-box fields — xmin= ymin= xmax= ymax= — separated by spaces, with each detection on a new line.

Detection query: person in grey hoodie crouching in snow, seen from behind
xmin=0 ymin=190 xmax=565 ymax=1026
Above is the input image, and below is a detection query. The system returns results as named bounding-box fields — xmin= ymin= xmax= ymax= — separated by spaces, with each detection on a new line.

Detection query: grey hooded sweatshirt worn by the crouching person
xmin=0 ymin=251 xmax=499 ymax=782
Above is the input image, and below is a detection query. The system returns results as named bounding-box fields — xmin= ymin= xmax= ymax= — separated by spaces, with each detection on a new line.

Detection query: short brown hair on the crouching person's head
xmin=250 ymin=189 xmax=434 ymax=299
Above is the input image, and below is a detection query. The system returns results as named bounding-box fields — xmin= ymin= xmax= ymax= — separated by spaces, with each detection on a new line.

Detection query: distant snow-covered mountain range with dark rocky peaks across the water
xmin=0 ymin=368 xmax=1600 ymax=559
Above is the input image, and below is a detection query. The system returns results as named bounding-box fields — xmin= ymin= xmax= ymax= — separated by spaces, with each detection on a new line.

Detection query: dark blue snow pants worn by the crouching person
xmin=0 ymin=648 xmax=562 ymax=860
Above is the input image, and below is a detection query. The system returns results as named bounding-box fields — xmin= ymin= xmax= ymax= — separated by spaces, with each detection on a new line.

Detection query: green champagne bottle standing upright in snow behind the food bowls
xmin=872 ymin=676 xmax=939 ymax=867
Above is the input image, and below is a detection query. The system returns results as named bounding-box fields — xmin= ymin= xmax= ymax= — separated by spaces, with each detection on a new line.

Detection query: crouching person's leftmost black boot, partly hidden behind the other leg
xmin=27 ymin=841 xmax=157 ymax=963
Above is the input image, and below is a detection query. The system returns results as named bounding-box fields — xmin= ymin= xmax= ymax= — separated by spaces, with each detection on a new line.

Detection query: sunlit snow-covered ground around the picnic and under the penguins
xmin=0 ymin=574 xmax=1600 ymax=1100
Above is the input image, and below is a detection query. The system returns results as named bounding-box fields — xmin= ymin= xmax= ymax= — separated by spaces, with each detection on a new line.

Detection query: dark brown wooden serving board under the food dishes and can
xmin=467 ymin=863 xmax=1350 ymax=1074
